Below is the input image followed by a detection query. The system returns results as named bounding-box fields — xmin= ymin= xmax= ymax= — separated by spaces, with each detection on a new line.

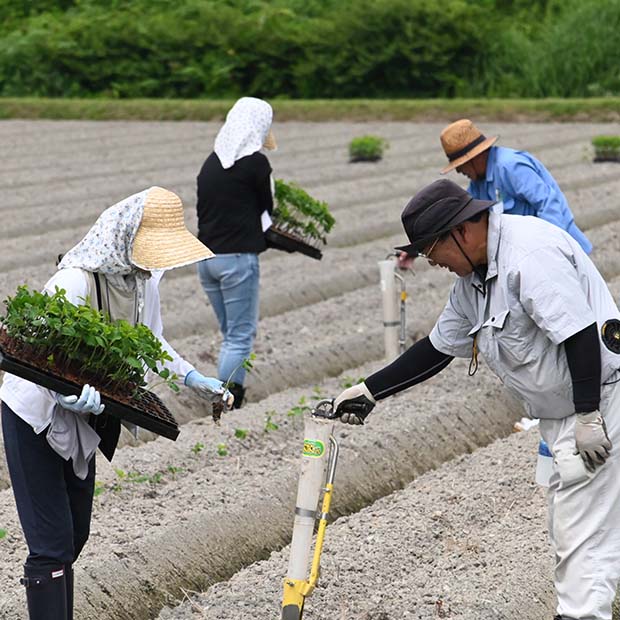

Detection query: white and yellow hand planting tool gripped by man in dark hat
xmin=282 ymin=400 xmax=338 ymax=620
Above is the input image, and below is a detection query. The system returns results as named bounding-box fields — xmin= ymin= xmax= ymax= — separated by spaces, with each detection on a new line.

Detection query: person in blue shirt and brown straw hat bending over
xmin=441 ymin=119 xmax=592 ymax=254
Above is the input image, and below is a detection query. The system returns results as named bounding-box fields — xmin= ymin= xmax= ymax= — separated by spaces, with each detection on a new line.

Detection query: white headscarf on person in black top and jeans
xmin=213 ymin=97 xmax=273 ymax=169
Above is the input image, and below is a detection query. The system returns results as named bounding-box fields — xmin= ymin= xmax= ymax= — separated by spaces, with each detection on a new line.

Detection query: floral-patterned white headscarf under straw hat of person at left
xmin=58 ymin=188 xmax=152 ymax=311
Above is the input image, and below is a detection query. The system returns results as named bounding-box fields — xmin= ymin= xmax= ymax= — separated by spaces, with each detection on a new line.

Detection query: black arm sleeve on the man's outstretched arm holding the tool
xmin=365 ymin=336 xmax=454 ymax=400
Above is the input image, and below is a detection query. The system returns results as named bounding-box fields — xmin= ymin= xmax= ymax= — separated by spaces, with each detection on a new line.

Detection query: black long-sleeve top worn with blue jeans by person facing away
xmin=196 ymin=151 xmax=273 ymax=254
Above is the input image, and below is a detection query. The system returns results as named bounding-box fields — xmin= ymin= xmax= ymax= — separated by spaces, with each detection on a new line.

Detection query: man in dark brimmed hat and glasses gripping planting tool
xmin=334 ymin=179 xmax=620 ymax=620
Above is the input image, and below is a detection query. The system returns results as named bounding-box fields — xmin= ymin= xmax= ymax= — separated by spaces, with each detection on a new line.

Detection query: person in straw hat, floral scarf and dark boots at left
xmin=0 ymin=187 xmax=232 ymax=620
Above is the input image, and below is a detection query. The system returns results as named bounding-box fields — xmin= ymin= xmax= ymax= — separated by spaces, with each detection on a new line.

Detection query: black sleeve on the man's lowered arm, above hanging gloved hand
xmin=564 ymin=323 xmax=601 ymax=413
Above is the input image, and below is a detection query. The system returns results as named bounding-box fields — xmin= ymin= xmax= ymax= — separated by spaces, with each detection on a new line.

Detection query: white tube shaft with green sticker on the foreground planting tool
xmin=287 ymin=416 xmax=334 ymax=581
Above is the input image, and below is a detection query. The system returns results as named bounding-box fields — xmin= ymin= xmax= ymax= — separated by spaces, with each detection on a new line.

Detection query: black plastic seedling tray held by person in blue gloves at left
xmin=0 ymin=347 xmax=179 ymax=441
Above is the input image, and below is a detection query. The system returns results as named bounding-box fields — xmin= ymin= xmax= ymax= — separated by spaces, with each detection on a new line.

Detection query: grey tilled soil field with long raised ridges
xmin=0 ymin=121 xmax=620 ymax=620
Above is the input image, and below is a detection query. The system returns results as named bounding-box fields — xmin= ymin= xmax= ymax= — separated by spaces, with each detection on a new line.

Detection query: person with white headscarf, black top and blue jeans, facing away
xmin=197 ymin=97 xmax=276 ymax=407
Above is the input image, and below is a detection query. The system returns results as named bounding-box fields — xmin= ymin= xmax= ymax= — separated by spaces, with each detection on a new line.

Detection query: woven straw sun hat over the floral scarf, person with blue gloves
xmin=131 ymin=187 xmax=214 ymax=271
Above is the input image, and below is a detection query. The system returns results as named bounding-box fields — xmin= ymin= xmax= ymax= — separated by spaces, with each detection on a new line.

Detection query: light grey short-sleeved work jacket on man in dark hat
xmin=430 ymin=213 xmax=620 ymax=419
